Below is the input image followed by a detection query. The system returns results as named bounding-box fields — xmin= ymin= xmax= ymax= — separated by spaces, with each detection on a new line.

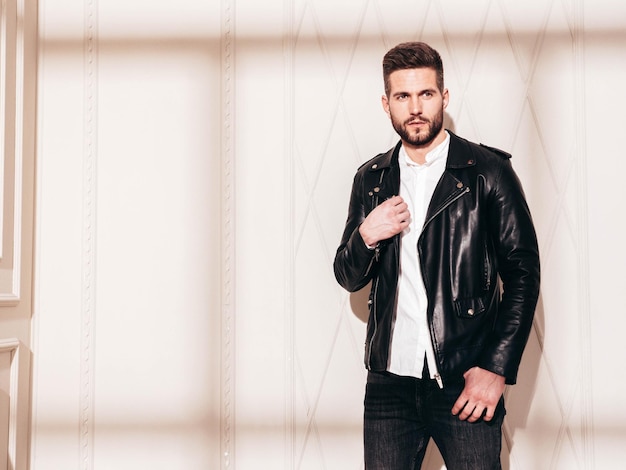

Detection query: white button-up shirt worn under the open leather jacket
xmin=387 ymin=133 xmax=450 ymax=385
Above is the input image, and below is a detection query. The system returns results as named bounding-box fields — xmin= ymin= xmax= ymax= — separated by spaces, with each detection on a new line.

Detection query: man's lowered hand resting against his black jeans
xmin=452 ymin=367 xmax=505 ymax=423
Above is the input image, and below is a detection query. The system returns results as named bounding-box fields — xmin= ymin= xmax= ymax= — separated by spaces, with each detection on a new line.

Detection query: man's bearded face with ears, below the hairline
xmin=382 ymin=68 xmax=448 ymax=148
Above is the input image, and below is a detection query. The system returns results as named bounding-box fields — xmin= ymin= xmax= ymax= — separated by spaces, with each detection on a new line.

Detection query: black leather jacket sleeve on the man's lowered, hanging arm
xmin=479 ymin=159 xmax=540 ymax=384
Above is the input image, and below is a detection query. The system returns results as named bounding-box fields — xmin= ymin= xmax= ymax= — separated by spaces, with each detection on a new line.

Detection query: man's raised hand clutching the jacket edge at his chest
xmin=359 ymin=196 xmax=411 ymax=246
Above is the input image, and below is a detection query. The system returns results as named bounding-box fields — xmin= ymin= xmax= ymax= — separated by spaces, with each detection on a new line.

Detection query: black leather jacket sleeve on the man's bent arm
xmin=333 ymin=172 xmax=378 ymax=292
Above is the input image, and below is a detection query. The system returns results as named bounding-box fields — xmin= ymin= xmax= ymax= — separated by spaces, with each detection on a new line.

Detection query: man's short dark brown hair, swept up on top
xmin=383 ymin=42 xmax=443 ymax=96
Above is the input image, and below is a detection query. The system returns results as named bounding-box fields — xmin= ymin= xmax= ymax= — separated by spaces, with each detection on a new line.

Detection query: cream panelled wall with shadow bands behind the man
xmin=31 ymin=0 xmax=626 ymax=470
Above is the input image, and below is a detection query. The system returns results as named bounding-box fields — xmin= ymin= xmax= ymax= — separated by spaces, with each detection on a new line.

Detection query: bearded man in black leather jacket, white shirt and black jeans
xmin=334 ymin=43 xmax=539 ymax=470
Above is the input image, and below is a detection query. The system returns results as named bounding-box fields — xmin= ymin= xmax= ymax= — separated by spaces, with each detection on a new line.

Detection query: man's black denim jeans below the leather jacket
xmin=363 ymin=372 xmax=506 ymax=470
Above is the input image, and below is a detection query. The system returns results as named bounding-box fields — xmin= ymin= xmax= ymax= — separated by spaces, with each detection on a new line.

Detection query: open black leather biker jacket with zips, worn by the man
xmin=334 ymin=132 xmax=539 ymax=384
